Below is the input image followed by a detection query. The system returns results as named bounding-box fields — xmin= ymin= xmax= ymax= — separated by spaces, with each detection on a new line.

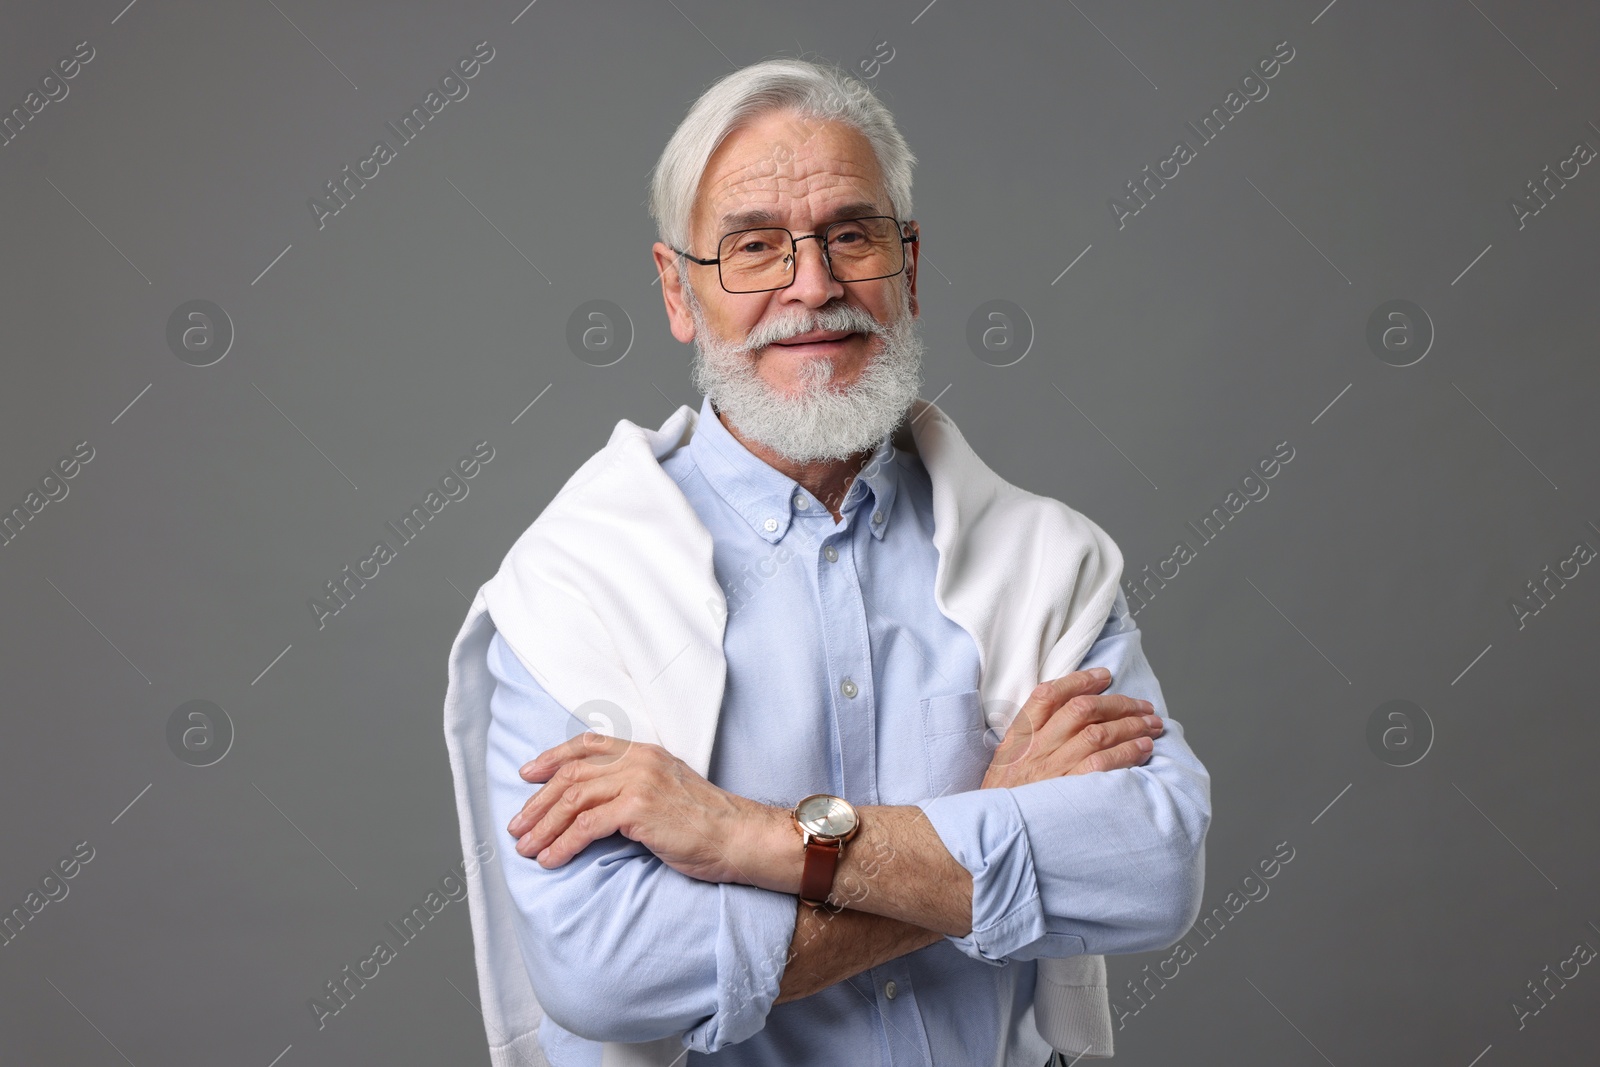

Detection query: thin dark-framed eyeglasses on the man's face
xmin=672 ymin=214 xmax=917 ymax=293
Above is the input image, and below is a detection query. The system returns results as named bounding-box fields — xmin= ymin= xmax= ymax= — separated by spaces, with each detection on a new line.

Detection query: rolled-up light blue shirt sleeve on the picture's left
xmin=486 ymin=633 xmax=795 ymax=1053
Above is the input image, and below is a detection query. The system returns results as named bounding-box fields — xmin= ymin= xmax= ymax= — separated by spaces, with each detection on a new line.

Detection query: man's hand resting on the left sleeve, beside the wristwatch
xmin=506 ymin=733 xmax=784 ymax=885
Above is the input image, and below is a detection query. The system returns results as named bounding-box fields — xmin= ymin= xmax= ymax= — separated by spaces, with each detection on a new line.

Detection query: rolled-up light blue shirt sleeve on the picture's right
xmin=918 ymin=592 xmax=1211 ymax=965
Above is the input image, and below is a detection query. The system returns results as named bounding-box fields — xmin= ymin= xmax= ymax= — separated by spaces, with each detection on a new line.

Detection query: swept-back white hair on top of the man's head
xmin=650 ymin=58 xmax=917 ymax=250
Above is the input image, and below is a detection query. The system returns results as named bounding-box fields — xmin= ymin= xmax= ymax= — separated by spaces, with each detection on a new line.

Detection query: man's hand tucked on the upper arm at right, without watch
xmin=981 ymin=667 xmax=1163 ymax=789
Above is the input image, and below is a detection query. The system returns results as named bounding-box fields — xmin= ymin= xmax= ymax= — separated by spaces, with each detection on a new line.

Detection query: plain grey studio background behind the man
xmin=0 ymin=0 xmax=1600 ymax=1067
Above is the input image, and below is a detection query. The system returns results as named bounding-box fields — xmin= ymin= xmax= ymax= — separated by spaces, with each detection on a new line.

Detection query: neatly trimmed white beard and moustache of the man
xmin=683 ymin=275 xmax=923 ymax=462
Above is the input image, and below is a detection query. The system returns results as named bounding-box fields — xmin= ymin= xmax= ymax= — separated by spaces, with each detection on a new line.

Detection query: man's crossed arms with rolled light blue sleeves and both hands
xmin=488 ymin=601 xmax=1210 ymax=1051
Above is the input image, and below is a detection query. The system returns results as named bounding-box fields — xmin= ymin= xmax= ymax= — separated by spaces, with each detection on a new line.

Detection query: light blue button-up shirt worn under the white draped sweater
xmin=488 ymin=400 xmax=1211 ymax=1067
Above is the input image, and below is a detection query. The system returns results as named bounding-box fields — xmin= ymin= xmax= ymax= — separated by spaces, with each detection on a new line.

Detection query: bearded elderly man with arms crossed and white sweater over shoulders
xmin=446 ymin=59 xmax=1211 ymax=1067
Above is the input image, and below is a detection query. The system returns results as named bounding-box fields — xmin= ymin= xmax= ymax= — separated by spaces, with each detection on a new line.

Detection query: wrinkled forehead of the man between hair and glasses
xmin=691 ymin=112 xmax=893 ymax=240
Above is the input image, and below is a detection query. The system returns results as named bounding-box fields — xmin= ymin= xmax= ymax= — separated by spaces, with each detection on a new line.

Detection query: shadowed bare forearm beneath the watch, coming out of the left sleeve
xmin=773 ymin=904 xmax=944 ymax=1005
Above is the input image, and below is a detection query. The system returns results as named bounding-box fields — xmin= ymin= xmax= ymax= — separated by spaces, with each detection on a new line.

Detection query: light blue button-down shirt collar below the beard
xmin=690 ymin=397 xmax=899 ymax=544
